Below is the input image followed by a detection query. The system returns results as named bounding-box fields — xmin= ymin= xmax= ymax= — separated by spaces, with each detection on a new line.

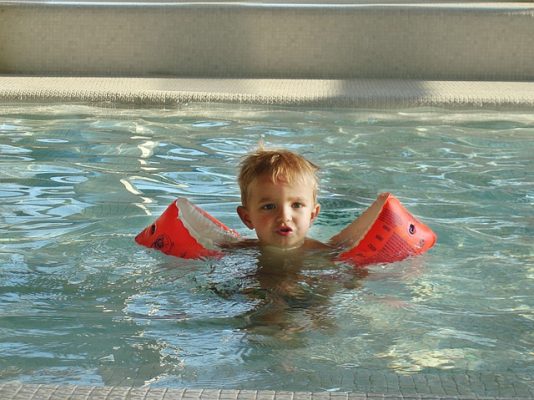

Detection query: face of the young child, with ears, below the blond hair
xmin=237 ymin=176 xmax=320 ymax=249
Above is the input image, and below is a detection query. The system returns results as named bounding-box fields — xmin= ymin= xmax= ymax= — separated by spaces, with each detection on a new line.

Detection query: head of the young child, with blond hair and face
xmin=237 ymin=149 xmax=320 ymax=248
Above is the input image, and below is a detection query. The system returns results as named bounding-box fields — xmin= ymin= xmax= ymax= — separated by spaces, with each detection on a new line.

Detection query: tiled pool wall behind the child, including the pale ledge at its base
xmin=0 ymin=0 xmax=534 ymax=106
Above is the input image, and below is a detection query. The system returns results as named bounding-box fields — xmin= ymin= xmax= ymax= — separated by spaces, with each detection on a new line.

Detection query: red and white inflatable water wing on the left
xmin=135 ymin=198 xmax=239 ymax=258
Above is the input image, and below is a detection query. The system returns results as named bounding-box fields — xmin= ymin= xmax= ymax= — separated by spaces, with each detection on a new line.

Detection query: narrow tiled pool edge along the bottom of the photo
xmin=0 ymin=383 xmax=527 ymax=400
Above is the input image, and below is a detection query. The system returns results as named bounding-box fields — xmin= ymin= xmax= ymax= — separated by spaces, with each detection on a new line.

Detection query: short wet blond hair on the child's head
xmin=237 ymin=147 xmax=319 ymax=205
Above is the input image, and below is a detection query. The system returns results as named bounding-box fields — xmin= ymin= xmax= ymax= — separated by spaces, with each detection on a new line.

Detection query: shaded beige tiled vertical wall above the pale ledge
xmin=0 ymin=0 xmax=534 ymax=81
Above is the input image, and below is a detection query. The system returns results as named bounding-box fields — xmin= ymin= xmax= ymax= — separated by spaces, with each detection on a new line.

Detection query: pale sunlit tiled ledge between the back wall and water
xmin=0 ymin=75 xmax=534 ymax=108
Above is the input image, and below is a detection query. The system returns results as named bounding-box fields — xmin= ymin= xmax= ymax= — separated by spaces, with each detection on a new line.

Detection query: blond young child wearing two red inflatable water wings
xmin=135 ymin=148 xmax=436 ymax=266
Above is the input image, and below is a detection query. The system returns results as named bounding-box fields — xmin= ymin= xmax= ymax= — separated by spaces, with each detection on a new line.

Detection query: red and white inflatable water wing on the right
xmin=329 ymin=193 xmax=436 ymax=266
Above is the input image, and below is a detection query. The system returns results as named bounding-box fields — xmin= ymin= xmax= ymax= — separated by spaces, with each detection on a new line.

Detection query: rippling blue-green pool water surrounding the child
xmin=0 ymin=104 xmax=534 ymax=397
